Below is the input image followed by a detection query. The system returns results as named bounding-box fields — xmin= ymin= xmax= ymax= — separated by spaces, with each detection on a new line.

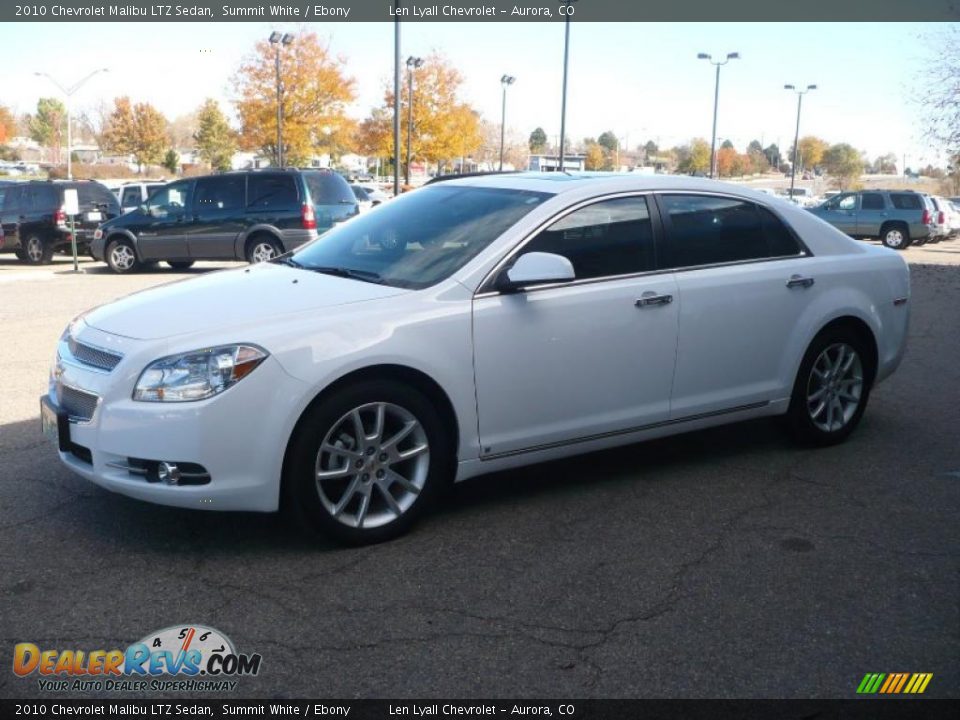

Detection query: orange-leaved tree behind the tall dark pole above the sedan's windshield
xmin=359 ymin=53 xmax=483 ymax=173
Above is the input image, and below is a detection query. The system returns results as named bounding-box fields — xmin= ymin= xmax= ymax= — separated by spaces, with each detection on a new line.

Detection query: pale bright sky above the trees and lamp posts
xmin=0 ymin=22 xmax=945 ymax=167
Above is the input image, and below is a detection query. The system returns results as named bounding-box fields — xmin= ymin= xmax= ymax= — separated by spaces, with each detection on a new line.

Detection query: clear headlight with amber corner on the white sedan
xmin=133 ymin=345 xmax=268 ymax=402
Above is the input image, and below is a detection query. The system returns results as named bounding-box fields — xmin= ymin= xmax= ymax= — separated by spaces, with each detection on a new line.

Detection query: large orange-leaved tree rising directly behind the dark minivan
xmin=233 ymin=31 xmax=356 ymax=165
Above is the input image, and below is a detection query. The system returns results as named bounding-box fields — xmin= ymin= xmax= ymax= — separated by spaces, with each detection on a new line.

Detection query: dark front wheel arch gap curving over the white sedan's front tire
xmin=280 ymin=363 xmax=460 ymax=500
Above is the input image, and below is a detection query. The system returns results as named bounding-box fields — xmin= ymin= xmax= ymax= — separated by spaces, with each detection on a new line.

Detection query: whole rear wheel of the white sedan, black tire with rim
xmin=787 ymin=326 xmax=873 ymax=446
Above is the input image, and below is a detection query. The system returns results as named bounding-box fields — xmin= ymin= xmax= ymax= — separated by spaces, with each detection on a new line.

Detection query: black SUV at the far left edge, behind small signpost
xmin=0 ymin=180 xmax=120 ymax=265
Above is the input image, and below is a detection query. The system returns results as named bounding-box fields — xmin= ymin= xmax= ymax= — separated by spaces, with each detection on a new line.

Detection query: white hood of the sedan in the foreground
xmin=84 ymin=263 xmax=410 ymax=340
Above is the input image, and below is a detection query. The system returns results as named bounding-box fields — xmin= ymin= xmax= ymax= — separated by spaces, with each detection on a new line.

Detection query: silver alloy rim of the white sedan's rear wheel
xmin=806 ymin=343 xmax=863 ymax=433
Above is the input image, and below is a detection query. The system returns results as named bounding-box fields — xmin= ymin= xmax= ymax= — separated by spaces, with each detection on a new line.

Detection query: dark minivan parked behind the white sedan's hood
xmin=91 ymin=169 xmax=359 ymax=273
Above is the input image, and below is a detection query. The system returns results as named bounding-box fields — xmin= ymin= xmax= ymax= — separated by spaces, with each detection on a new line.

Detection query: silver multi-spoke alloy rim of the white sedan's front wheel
xmin=315 ymin=402 xmax=430 ymax=529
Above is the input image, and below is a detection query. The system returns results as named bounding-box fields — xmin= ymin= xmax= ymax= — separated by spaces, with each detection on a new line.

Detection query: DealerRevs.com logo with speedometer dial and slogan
xmin=13 ymin=625 xmax=262 ymax=692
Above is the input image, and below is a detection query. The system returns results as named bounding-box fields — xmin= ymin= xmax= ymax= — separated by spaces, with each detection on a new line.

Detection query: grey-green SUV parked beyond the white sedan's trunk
xmin=808 ymin=190 xmax=935 ymax=250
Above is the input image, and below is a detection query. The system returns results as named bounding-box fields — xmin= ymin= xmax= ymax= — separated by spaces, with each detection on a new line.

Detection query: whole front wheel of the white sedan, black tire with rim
xmin=283 ymin=380 xmax=453 ymax=545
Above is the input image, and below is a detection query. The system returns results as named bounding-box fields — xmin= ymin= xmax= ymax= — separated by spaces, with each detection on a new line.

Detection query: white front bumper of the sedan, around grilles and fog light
xmin=44 ymin=326 xmax=303 ymax=512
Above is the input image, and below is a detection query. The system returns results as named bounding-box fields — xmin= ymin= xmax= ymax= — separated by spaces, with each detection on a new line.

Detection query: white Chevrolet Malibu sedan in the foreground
xmin=41 ymin=173 xmax=910 ymax=543
